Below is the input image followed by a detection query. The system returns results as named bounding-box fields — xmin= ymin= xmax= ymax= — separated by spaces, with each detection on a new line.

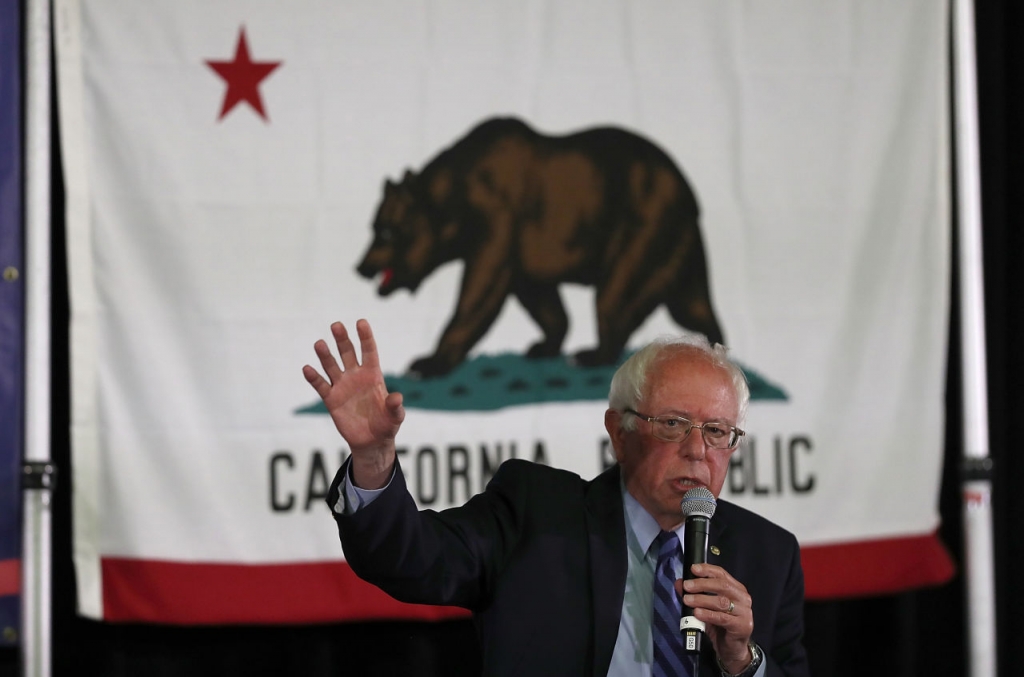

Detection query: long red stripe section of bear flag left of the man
xmin=100 ymin=558 xmax=469 ymax=625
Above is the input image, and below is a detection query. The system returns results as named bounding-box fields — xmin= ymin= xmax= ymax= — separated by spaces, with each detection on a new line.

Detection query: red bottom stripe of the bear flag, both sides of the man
xmin=99 ymin=535 xmax=955 ymax=625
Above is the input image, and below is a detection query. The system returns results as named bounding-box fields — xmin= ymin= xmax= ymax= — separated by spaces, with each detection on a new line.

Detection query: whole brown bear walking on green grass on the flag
xmin=357 ymin=118 xmax=723 ymax=377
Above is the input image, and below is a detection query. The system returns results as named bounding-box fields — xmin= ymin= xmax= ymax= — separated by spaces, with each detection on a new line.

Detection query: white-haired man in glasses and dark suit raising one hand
xmin=303 ymin=321 xmax=808 ymax=677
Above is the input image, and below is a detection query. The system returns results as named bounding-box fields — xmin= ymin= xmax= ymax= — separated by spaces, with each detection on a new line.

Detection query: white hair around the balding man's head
xmin=608 ymin=334 xmax=751 ymax=430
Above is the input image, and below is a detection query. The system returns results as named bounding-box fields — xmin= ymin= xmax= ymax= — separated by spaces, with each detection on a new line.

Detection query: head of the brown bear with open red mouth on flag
xmin=356 ymin=171 xmax=452 ymax=296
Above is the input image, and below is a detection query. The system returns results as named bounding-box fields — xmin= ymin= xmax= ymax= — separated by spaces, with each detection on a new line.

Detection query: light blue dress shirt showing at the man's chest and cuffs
xmin=334 ymin=466 xmax=767 ymax=677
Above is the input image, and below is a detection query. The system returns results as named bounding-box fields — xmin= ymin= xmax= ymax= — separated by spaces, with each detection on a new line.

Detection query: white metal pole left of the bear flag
xmin=22 ymin=0 xmax=52 ymax=677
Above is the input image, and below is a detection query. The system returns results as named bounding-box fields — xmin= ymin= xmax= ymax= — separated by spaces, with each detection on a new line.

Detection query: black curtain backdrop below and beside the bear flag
xmin=0 ymin=0 xmax=1024 ymax=677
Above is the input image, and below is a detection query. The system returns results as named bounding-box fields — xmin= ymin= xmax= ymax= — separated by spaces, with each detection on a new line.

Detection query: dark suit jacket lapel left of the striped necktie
xmin=587 ymin=466 xmax=627 ymax=675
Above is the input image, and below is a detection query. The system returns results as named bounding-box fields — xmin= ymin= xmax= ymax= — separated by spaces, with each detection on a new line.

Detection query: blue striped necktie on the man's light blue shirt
xmin=650 ymin=532 xmax=692 ymax=677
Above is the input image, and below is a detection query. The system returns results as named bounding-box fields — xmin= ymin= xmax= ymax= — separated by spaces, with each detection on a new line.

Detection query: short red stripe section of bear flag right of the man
xmin=800 ymin=534 xmax=955 ymax=599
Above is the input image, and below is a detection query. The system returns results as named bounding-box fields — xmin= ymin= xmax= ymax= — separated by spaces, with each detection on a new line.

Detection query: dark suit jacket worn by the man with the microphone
xmin=328 ymin=460 xmax=808 ymax=677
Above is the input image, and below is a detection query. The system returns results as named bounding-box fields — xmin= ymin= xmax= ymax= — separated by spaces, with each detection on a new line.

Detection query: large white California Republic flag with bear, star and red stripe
xmin=55 ymin=0 xmax=951 ymax=623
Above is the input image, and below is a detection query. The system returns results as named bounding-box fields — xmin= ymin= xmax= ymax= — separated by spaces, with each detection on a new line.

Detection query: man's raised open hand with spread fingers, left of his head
xmin=302 ymin=320 xmax=406 ymax=489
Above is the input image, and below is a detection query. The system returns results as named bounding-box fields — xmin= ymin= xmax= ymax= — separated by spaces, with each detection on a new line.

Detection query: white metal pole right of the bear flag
xmin=953 ymin=0 xmax=996 ymax=677
